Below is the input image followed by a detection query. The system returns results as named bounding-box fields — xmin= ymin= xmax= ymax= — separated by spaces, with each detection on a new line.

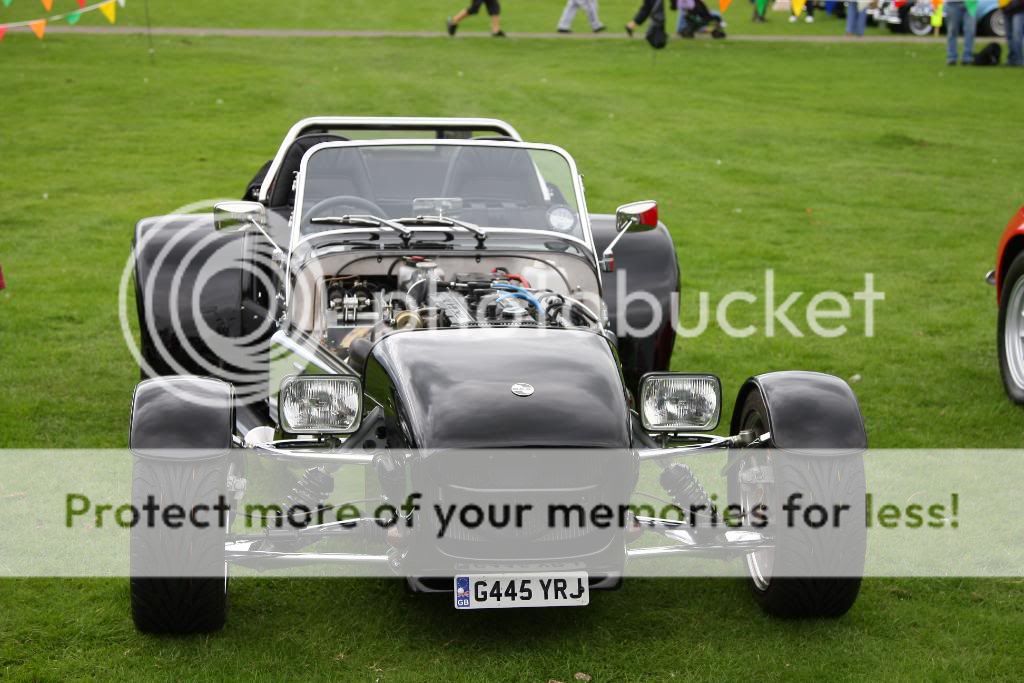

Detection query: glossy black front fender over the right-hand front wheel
xmin=731 ymin=371 xmax=867 ymax=452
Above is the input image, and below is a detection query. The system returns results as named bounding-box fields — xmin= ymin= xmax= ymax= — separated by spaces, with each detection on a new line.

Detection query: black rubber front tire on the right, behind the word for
xmin=729 ymin=391 xmax=866 ymax=617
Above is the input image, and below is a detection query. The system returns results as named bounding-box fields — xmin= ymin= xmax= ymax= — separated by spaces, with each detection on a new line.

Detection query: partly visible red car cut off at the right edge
xmin=986 ymin=207 xmax=1024 ymax=404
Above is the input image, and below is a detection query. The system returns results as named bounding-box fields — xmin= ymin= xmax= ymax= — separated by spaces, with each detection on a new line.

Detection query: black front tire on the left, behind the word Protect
xmin=131 ymin=456 xmax=228 ymax=634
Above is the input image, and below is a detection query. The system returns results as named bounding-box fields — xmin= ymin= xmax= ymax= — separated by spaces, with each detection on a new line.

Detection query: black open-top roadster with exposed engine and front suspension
xmin=130 ymin=117 xmax=866 ymax=633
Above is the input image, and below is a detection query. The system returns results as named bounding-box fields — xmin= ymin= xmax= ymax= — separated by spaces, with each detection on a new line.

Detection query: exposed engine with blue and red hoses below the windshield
xmin=324 ymin=256 xmax=600 ymax=362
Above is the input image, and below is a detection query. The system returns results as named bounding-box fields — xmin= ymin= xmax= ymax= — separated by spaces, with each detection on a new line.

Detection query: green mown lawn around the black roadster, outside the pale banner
xmin=0 ymin=6 xmax=1024 ymax=681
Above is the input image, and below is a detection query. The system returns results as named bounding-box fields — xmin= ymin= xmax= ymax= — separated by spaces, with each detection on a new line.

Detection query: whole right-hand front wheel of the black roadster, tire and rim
xmin=729 ymin=391 xmax=866 ymax=617
